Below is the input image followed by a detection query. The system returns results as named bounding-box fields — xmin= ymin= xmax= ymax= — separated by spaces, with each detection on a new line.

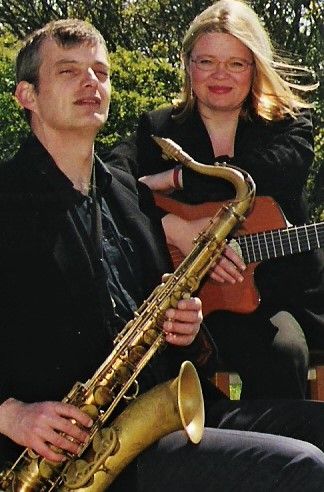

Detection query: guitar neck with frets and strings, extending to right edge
xmin=235 ymin=222 xmax=324 ymax=264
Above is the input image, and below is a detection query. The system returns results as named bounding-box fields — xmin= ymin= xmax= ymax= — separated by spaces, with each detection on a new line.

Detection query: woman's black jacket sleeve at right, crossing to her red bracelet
xmin=183 ymin=112 xmax=314 ymax=222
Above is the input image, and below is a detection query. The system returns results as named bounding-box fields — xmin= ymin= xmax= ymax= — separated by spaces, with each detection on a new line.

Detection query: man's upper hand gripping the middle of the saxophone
xmin=163 ymin=297 xmax=203 ymax=346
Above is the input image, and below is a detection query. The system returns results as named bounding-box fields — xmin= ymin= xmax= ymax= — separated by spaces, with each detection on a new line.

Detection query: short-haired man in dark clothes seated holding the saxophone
xmin=0 ymin=20 xmax=324 ymax=492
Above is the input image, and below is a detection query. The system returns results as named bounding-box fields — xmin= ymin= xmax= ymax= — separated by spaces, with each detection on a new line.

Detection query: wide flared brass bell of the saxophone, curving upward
xmin=58 ymin=361 xmax=205 ymax=492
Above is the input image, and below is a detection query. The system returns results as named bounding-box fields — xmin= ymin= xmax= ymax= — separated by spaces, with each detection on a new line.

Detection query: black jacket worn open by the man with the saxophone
xmin=0 ymin=137 xmax=218 ymax=459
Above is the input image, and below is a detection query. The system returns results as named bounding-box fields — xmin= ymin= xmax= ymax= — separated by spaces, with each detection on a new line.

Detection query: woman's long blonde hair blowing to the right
xmin=177 ymin=0 xmax=318 ymax=120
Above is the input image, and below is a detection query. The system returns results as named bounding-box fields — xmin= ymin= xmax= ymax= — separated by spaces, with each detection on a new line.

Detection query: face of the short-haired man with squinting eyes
xmin=27 ymin=40 xmax=111 ymax=135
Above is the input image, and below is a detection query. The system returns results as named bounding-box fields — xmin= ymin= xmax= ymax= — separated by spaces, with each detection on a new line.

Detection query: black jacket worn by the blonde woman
xmin=106 ymin=107 xmax=324 ymax=333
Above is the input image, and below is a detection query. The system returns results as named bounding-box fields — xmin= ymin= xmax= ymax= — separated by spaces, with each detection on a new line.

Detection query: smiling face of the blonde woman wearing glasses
xmin=188 ymin=33 xmax=254 ymax=115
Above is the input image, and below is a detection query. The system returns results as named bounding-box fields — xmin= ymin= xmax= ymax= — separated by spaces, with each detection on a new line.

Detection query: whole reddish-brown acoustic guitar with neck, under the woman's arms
xmin=154 ymin=193 xmax=324 ymax=316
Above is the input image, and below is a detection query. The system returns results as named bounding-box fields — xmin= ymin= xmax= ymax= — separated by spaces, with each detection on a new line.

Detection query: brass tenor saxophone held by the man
xmin=0 ymin=137 xmax=255 ymax=492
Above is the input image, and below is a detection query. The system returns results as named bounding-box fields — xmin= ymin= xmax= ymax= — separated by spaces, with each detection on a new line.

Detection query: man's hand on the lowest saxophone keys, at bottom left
xmin=0 ymin=398 xmax=92 ymax=462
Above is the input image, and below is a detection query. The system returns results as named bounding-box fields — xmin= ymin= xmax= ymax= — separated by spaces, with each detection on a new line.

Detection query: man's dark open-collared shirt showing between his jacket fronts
xmin=37 ymin=152 xmax=142 ymax=339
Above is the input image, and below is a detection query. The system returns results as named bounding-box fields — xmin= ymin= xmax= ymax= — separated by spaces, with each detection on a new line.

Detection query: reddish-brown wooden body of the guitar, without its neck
xmin=154 ymin=193 xmax=287 ymax=316
